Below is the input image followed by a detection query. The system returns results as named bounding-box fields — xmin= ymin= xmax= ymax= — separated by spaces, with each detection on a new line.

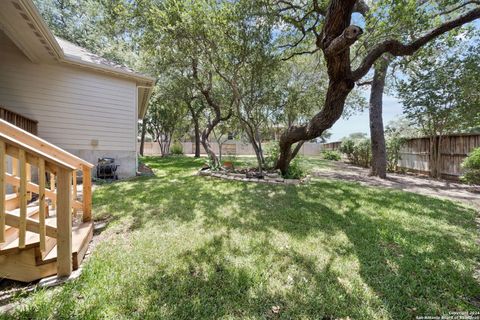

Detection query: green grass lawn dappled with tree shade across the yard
xmin=4 ymin=158 xmax=480 ymax=319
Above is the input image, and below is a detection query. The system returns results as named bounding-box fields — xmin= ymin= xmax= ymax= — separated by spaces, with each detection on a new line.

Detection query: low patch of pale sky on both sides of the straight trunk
xmin=328 ymin=95 xmax=402 ymax=142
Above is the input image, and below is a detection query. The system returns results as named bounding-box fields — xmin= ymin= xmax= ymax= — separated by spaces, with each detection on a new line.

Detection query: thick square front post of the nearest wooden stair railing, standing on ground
xmin=57 ymin=168 xmax=72 ymax=277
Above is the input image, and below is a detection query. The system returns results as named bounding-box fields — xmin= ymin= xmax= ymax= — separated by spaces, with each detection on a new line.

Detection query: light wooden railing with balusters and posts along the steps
xmin=0 ymin=119 xmax=93 ymax=276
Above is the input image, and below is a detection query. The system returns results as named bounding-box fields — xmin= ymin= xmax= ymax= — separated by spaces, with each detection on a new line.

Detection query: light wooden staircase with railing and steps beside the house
xmin=0 ymin=119 xmax=93 ymax=282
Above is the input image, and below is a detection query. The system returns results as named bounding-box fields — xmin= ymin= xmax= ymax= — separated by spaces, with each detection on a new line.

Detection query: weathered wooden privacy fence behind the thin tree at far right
xmin=398 ymin=134 xmax=480 ymax=179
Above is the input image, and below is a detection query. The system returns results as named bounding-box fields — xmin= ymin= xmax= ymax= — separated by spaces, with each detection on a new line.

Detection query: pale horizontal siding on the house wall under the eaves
xmin=0 ymin=32 xmax=137 ymax=177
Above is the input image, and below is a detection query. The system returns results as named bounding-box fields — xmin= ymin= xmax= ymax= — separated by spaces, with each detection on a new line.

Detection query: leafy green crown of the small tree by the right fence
xmin=398 ymin=44 xmax=480 ymax=135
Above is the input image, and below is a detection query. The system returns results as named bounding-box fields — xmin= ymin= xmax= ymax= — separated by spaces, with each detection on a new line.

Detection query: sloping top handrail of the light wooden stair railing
xmin=0 ymin=119 xmax=93 ymax=169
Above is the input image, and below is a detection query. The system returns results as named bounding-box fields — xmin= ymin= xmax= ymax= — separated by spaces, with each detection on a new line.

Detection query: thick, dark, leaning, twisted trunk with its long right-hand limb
xmin=277 ymin=0 xmax=480 ymax=173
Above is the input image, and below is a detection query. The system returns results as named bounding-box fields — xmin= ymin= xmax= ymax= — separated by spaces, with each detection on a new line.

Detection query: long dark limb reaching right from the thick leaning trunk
xmin=351 ymin=7 xmax=480 ymax=81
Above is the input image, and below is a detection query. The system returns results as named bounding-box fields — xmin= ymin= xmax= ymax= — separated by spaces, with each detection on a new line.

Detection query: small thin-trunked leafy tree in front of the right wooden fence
xmin=398 ymin=52 xmax=480 ymax=177
